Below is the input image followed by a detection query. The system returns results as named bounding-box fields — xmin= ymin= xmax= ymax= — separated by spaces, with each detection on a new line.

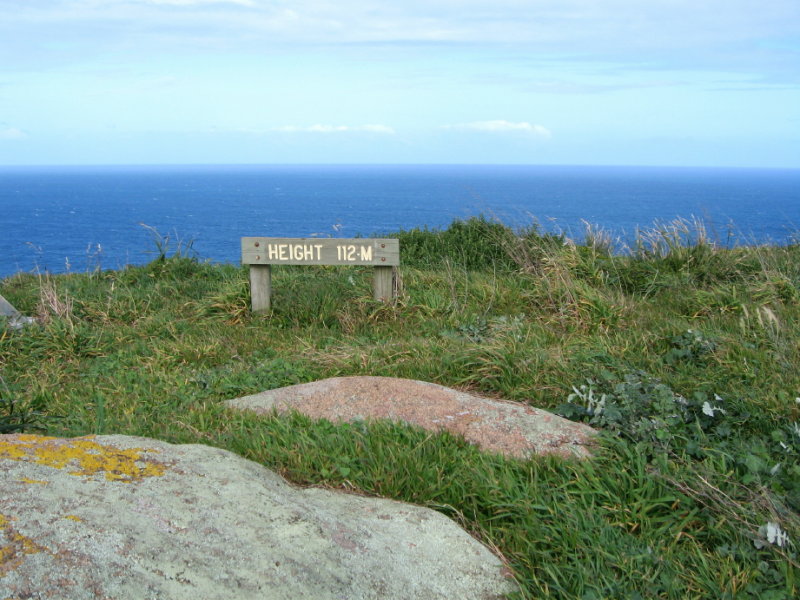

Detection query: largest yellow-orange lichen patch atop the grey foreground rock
xmin=0 ymin=434 xmax=164 ymax=482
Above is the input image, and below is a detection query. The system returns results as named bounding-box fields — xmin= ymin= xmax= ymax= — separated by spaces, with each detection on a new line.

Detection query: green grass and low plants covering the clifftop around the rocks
xmin=0 ymin=218 xmax=800 ymax=600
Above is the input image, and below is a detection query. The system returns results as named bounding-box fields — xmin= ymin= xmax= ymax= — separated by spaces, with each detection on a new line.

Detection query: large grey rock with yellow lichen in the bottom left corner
xmin=0 ymin=435 xmax=516 ymax=600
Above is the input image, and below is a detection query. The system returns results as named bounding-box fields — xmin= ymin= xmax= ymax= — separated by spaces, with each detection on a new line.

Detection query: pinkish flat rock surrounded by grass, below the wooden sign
xmin=227 ymin=377 xmax=594 ymax=458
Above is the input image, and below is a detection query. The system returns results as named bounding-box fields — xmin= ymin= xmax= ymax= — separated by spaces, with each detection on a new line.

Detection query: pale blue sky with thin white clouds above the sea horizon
xmin=0 ymin=0 xmax=800 ymax=168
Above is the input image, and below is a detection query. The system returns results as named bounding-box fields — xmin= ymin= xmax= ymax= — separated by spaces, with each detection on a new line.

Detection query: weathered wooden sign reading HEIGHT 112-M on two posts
xmin=242 ymin=237 xmax=400 ymax=313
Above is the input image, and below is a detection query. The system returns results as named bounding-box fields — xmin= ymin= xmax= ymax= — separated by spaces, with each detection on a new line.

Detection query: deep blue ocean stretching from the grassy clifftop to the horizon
xmin=0 ymin=165 xmax=800 ymax=277
